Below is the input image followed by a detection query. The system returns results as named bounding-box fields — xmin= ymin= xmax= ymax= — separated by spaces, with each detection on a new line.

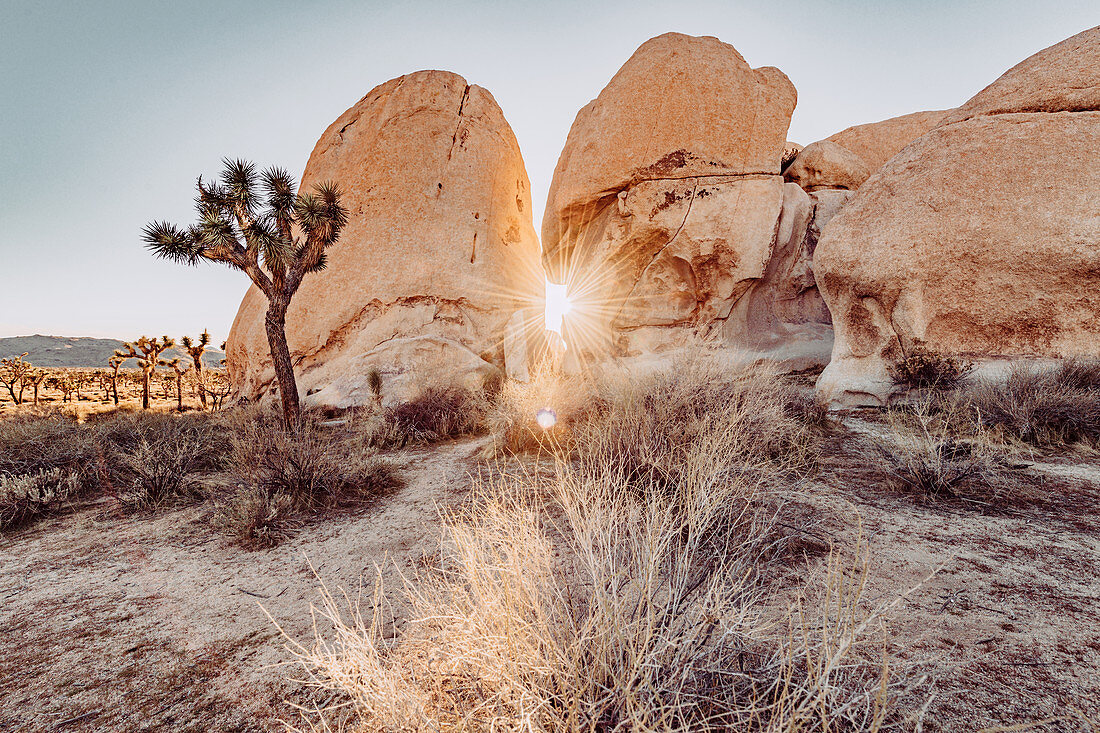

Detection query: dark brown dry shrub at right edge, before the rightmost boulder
xmin=956 ymin=360 xmax=1100 ymax=448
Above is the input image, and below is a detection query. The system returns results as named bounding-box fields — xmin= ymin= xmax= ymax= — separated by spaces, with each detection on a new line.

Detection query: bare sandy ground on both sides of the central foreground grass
xmin=0 ymin=422 xmax=1100 ymax=733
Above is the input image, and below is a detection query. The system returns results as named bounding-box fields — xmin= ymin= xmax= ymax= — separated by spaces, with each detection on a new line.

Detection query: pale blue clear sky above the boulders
xmin=0 ymin=0 xmax=1100 ymax=343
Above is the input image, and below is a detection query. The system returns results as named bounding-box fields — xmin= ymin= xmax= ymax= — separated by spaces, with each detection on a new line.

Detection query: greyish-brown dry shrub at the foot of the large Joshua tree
xmin=216 ymin=413 xmax=400 ymax=547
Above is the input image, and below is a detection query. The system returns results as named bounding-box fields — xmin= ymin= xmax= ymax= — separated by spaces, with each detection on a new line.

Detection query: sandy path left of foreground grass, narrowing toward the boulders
xmin=0 ymin=440 xmax=481 ymax=731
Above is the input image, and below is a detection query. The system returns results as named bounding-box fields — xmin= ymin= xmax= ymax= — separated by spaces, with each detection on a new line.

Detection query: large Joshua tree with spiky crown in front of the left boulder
xmin=142 ymin=158 xmax=348 ymax=427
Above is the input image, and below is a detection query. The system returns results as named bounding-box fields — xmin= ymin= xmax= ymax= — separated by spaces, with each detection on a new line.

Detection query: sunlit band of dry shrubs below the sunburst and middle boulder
xmin=488 ymin=359 xmax=829 ymax=468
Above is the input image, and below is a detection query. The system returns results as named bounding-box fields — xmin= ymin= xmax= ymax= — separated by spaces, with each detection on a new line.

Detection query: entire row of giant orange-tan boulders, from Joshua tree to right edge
xmin=228 ymin=28 xmax=1100 ymax=407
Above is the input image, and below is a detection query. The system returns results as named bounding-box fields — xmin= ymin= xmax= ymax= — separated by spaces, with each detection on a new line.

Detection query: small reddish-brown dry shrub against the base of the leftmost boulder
xmin=372 ymin=387 xmax=488 ymax=448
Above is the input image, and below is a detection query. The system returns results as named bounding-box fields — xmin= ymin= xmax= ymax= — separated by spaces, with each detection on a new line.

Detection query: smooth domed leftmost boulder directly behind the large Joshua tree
xmin=228 ymin=72 xmax=542 ymax=406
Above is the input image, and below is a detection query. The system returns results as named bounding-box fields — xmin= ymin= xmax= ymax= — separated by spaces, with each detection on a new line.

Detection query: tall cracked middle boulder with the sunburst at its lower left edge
xmin=542 ymin=33 xmax=820 ymax=359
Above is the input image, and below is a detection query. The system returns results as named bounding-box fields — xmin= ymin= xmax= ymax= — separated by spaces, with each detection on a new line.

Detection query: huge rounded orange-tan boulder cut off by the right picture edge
xmin=814 ymin=28 xmax=1100 ymax=405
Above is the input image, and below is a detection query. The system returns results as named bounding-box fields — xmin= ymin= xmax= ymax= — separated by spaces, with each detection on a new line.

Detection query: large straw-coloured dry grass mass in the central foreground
xmin=283 ymin=360 xmax=910 ymax=733
